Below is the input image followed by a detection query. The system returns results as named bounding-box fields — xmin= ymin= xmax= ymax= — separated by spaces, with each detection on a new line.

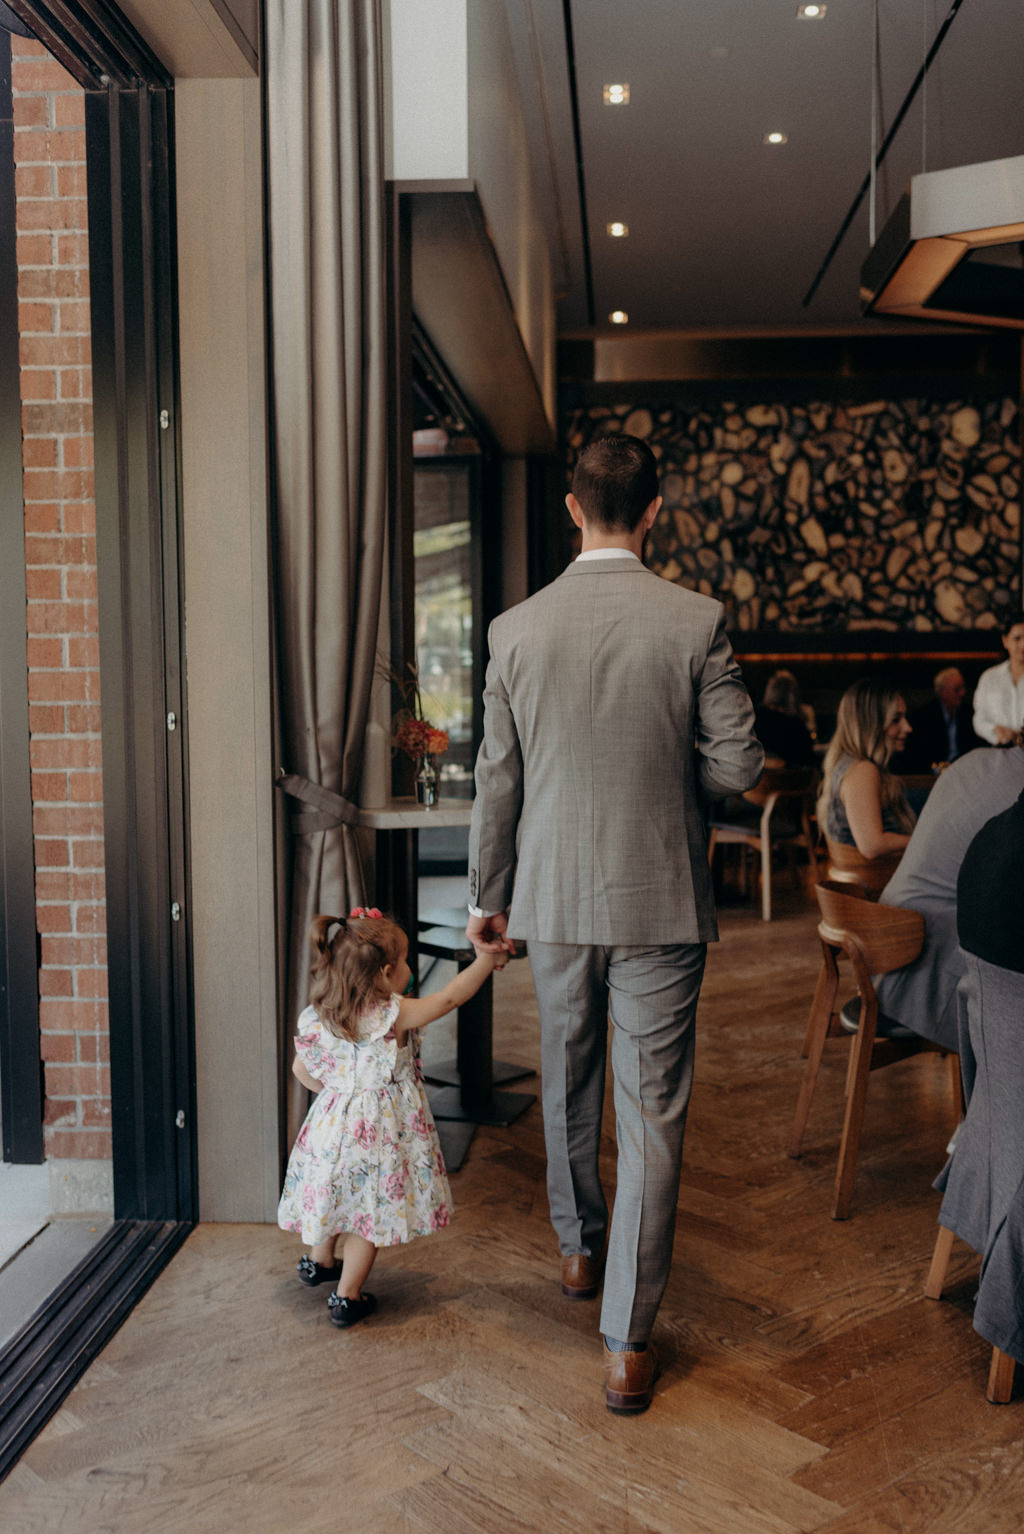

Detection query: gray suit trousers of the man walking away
xmin=529 ymin=939 xmax=707 ymax=1342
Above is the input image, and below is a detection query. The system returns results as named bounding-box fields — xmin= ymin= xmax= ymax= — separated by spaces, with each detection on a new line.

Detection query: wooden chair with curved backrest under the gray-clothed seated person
xmin=788 ymin=881 xmax=960 ymax=1220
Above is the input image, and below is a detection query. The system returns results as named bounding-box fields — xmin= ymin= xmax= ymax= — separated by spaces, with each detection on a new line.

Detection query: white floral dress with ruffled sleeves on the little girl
xmin=277 ymin=996 xmax=452 ymax=1246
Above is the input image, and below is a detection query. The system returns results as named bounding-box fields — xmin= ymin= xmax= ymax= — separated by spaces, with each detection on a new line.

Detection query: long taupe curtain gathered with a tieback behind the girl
xmin=265 ymin=0 xmax=388 ymax=1138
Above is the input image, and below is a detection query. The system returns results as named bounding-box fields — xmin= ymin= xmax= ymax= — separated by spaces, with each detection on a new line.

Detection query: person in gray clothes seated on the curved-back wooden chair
xmin=875 ymin=746 xmax=1024 ymax=1055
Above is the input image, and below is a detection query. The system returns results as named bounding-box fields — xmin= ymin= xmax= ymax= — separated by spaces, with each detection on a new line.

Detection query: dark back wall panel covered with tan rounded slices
xmin=566 ymin=399 xmax=1021 ymax=632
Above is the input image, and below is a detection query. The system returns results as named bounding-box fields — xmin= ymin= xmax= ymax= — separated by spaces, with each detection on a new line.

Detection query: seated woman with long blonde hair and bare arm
xmin=817 ymin=678 xmax=914 ymax=858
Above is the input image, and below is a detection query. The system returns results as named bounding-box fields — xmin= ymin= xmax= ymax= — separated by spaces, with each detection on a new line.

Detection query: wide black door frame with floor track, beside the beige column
xmin=0 ymin=0 xmax=198 ymax=1479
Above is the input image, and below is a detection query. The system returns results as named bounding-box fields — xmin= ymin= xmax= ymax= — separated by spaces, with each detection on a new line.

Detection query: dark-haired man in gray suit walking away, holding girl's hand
xmin=466 ymin=436 xmax=763 ymax=1411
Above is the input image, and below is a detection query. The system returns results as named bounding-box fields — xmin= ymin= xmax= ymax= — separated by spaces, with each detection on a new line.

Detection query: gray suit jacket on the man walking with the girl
xmin=469 ymin=558 xmax=763 ymax=945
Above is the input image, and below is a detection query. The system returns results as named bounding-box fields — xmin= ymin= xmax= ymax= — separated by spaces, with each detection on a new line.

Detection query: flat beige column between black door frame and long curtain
xmin=175 ymin=78 xmax=281 ymax=1221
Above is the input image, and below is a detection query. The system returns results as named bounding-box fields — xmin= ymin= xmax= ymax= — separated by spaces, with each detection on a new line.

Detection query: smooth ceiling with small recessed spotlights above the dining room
xmin=506 ymin=0 xmax=1024 ymax=334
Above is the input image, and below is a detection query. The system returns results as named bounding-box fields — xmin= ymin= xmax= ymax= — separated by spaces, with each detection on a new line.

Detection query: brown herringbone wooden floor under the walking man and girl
xmin=0 ymin=890 xmax=1024 ymax=1534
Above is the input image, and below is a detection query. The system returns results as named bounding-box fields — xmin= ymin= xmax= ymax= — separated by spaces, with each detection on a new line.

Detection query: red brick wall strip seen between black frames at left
xmin=12 ymin=37 xmax=110 ymax=1160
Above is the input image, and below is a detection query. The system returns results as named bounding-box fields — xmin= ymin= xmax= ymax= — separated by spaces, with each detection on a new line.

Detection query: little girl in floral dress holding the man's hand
xmin=277 ymin=907 xmax=507 ymax=1327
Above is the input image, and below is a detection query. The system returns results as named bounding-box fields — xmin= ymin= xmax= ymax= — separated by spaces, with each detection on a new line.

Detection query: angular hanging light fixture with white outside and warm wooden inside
xmin=860 ymin=155 xmax=1024 ymax=330
